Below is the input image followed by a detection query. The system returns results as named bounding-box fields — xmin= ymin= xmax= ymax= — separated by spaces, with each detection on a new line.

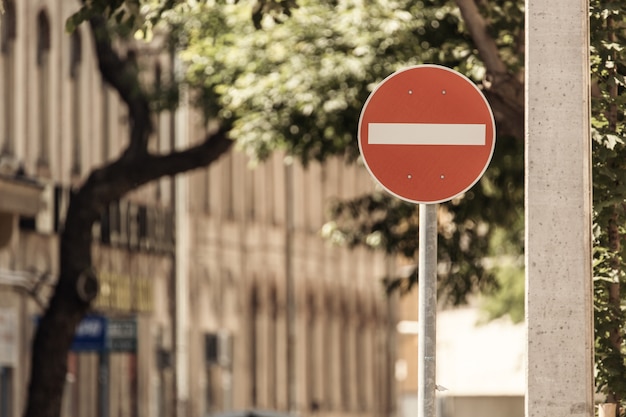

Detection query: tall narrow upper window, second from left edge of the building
xmin=36 ymin=11 xmax=50 ymax=168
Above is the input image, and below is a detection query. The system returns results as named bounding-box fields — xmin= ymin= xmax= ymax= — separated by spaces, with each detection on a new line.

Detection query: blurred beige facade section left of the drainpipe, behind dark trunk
xmin=0 ymin=0 xmax=174 ymax=417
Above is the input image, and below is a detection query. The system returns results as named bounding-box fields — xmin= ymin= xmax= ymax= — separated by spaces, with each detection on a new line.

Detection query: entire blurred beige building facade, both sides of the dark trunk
xmin=0 ymin=0 xmax=395 ymax=417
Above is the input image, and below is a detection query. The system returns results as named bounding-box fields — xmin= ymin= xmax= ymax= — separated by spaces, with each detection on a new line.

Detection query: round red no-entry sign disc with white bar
xmin=358 ymin=65 xmax=496 ymax=204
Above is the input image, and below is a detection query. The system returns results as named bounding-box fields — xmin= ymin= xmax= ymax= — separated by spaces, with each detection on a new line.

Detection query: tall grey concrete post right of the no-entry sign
xmin=525 ymin=0 xmax=594 ymax=417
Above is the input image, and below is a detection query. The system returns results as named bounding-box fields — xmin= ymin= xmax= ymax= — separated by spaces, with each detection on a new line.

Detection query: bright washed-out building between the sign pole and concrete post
xmin=437 ymin=306 xmax=526 ymax=417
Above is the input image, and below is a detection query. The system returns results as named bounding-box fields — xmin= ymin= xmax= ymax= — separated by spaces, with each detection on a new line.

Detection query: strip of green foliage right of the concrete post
xmin=590 ymin=0 xmax=626 ymax=401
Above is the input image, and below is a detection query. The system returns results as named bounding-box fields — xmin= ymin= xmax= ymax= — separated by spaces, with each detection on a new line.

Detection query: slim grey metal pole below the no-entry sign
xmin=417 ymin=204 xmax=438 ymax=417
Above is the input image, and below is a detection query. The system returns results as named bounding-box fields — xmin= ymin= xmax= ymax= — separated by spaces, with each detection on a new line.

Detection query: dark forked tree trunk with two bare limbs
xmin=24 ymin=8 xmax=232 ymax=417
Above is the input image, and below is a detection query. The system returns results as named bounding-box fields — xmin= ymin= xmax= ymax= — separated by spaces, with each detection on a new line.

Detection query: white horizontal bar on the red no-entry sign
xmin=367 ymin=123 xmax=487 ymax=145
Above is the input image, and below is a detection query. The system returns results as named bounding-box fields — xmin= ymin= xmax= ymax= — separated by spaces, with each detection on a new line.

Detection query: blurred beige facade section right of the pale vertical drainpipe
xmin=182 ymin=106 xmax=394 ymax=416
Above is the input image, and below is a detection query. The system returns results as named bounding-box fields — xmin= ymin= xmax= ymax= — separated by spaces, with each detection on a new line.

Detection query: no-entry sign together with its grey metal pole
xmin=357 ymin=65 xmax=496 ymax=417
